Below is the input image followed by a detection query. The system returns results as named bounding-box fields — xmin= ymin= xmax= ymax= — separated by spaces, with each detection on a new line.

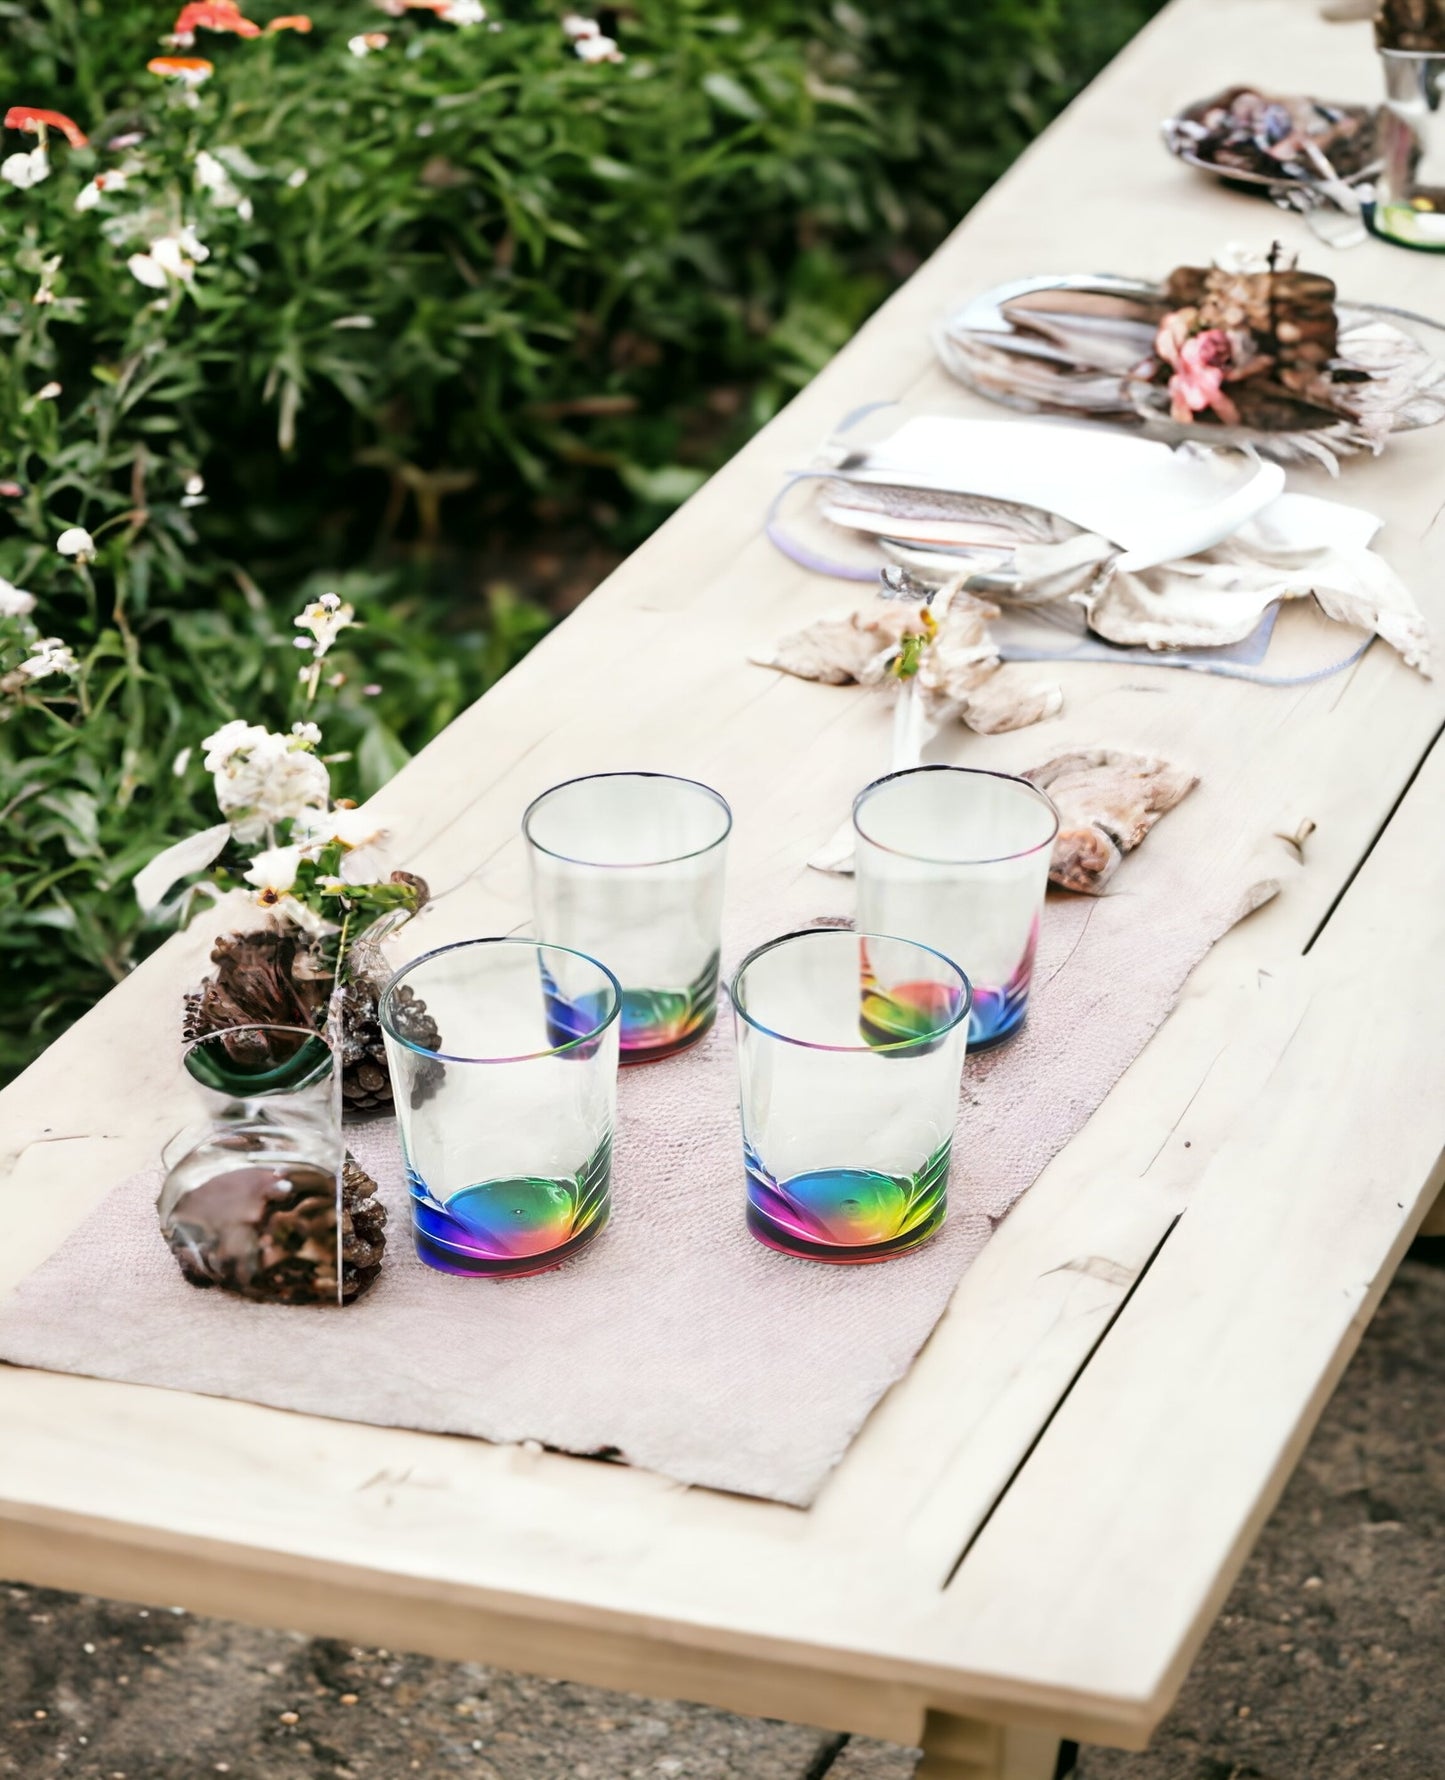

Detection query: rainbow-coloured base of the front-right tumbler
xmin=744 ymin=1141 xmax=952 ymax=1266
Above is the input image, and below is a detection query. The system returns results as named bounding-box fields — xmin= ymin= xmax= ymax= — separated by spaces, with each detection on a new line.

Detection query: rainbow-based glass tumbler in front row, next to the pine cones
xmin=381 ymin=940 xmax=621 ymax=1278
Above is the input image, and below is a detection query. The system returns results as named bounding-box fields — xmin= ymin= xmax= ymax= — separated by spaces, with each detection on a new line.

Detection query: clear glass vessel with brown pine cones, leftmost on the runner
xmin=157 ymin=1025 xmax=361 ymax=1305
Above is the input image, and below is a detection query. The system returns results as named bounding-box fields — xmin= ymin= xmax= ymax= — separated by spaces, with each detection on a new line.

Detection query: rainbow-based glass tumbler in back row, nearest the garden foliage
xmin=521 ymin=773 xmax=733 ymax=1063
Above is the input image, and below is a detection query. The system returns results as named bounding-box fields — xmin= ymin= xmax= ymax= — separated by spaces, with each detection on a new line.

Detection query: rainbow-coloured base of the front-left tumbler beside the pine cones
xmin=408 ymin=1139 xmax=612 ymax=1280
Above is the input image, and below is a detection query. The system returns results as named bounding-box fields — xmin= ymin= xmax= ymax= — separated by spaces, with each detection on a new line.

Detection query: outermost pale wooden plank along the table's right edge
xmin=918 ymin=733 xmax=1445 ymax=1727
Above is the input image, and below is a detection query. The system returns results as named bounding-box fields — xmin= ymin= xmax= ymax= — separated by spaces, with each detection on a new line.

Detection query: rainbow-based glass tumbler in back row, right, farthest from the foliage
xmin=852 ymin=765 xmax=1059 ymax=1050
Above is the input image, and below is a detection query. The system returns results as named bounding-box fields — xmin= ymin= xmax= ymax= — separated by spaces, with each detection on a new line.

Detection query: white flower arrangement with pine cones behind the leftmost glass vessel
xmin=135 ymin=593 xmax=440 ymax=1113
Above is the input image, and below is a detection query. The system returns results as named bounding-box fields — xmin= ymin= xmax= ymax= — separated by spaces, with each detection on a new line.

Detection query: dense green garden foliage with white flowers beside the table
xmin=0 ymin=0 xmax=1151 ymax=1077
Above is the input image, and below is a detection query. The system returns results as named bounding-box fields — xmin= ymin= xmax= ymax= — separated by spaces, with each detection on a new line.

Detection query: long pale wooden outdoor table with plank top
xmin=0 ymin=0 xmax=1445 ymax=1780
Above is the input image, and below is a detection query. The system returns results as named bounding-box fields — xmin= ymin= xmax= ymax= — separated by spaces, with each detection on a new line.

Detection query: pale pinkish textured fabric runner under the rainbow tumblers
xmin=0 ymin=833 xmax=1272 ymax=1506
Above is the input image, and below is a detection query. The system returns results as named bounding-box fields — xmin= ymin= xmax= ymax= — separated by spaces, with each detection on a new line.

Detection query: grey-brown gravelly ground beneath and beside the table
xmin=0 ymin=1242 xmax=1445 ymax=1780
